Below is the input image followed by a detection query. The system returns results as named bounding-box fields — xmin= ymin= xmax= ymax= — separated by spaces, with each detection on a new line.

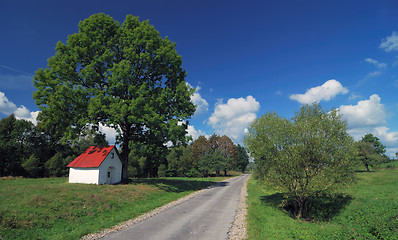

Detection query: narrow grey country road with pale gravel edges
xmin=104 ymin=174 xmax=249 ymax=240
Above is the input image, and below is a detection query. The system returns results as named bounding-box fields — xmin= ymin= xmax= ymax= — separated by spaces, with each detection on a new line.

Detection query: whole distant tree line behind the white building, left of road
xmin=0 ymin=114 xmax=249 ymax=178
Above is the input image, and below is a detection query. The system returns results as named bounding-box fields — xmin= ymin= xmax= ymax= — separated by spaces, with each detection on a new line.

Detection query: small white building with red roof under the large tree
xmin=66 ymin=145 xmax=122 ymax=185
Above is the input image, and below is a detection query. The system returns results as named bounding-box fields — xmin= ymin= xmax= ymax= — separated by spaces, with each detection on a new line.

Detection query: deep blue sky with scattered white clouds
xmin=0 ymin=0 xmax=398 ymax=156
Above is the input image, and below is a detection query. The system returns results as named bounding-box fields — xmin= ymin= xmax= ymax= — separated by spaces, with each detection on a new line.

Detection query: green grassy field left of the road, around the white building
xmin=0 ymin=175 xmax=227 ymax=239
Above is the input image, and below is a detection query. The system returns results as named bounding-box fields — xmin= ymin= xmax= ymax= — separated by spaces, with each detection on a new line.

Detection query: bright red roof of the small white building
xmin=66 ymin=145 xmax=118 ymax=168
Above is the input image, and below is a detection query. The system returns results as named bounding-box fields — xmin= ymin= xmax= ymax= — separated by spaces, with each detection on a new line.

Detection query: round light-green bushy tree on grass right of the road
xmin=245 ymin=104 xmax=356 ymax=218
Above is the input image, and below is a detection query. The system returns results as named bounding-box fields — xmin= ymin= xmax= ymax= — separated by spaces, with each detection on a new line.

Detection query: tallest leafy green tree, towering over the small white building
xmin=34 ymin=14 xmax=195 ymax=180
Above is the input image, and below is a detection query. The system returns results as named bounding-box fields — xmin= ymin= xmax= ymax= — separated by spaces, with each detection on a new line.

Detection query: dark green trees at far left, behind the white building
xmin=0 ymin=114 xmax=108 ymax=177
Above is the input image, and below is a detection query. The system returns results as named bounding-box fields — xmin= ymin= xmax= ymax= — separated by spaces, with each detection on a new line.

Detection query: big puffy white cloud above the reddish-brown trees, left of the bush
xmin=208 ymin=96 xmax=260 ymax=142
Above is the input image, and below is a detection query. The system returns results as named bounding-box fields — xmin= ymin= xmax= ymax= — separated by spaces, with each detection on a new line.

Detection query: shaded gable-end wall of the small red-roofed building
xmin=98 ymin=148 xmax=122 ymax=184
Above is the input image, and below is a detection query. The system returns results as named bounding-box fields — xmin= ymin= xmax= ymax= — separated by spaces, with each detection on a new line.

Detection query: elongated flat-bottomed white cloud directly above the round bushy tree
xmin=290 ymin=79 xmax=348 ymax=104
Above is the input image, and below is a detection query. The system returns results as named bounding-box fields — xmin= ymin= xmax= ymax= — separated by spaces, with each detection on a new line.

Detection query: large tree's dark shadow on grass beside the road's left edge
xmin=129 ymin=178 xmax=221 ymax=192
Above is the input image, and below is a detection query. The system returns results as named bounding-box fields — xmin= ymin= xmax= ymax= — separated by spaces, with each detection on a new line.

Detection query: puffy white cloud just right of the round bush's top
xmin=339 ymin=94 xmax=386 ymax=129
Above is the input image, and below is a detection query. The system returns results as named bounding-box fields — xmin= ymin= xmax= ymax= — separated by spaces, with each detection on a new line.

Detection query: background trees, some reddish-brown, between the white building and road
xmin=129 ymin=135 xmax=249 ymax=177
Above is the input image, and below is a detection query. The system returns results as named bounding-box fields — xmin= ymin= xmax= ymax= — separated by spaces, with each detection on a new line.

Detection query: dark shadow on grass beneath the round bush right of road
xmin=260 ymin=193 xmax=352 ymax=221
